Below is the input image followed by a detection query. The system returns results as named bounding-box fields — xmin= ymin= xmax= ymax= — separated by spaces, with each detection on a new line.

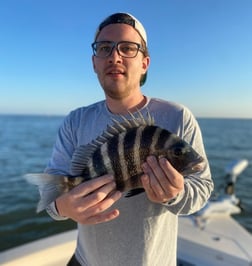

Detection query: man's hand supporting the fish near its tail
xmin=56 ymin=175 xmax=121 ymax=224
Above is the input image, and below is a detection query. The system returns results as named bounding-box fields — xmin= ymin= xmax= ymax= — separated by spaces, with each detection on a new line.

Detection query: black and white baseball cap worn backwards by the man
xmin=95 ymin=13 xmax=147 ymax=46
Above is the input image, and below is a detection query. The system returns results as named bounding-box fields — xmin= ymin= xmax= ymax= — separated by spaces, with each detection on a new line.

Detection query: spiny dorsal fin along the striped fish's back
xmin=71 ymin=111 xmax=154 ymax=175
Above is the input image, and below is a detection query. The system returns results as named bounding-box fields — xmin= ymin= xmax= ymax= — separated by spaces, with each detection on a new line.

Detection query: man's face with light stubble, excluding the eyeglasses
xmin=92 ymin=24 xmax=149 ymax=99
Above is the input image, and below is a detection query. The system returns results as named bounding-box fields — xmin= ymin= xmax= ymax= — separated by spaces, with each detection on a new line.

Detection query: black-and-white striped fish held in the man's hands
xmin=25 ymin=111 xmax=205 ymax=212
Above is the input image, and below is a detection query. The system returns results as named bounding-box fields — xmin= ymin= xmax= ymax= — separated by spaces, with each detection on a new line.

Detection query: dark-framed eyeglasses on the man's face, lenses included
xmin=92 ymin=41 xmax=144 ymax=58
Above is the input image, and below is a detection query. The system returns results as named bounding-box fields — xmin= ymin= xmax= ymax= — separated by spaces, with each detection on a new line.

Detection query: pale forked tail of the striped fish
xmin=24 ymin=173 xmax=82 ymax=212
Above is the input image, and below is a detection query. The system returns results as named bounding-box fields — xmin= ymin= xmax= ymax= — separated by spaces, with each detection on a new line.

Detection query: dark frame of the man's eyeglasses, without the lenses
xmin=91 ymin=41 xmax=144 ymax=58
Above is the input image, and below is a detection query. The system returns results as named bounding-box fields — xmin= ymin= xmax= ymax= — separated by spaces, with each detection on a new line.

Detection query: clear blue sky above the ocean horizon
xmin=0 ymin=0 xmax=252 ymax=118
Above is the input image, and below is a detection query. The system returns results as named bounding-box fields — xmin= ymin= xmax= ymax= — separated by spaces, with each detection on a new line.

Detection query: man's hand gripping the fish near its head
xmin=141 ymin=156 xmax=184 ymax=203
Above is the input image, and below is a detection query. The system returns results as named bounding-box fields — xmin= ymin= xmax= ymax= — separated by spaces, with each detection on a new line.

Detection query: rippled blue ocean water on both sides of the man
xmin=0 ymin=115 xmax=252 ymax=251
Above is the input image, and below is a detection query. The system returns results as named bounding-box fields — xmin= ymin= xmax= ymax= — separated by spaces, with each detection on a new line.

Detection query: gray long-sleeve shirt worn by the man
xmin=43 ymin=98 xmax=213 ymax=266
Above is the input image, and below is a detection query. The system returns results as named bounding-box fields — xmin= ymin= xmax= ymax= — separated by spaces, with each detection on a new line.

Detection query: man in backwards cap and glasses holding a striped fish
xmin=41 ymin=13 xmax=213 ymax=266
